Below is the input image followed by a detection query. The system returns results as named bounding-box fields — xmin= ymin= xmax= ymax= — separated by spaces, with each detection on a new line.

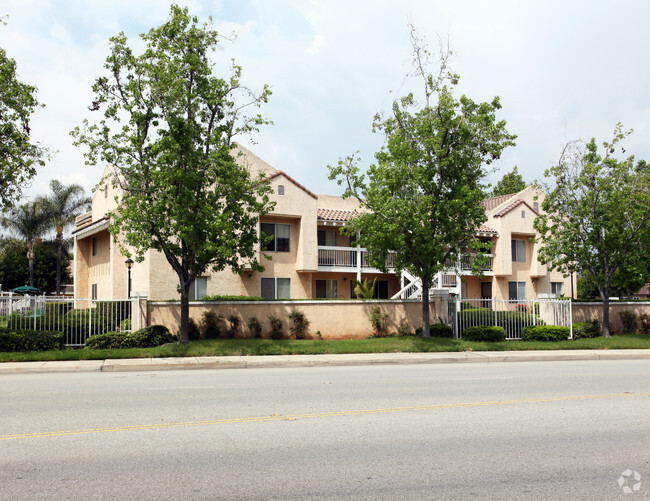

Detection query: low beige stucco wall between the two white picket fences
xmin=148 ymin=300 xmax=447 ymax=339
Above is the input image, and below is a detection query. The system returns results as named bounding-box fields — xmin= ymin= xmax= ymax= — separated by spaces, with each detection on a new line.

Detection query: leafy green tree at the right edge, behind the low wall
xmin=535 ymin=123 xmax=650 ymax=336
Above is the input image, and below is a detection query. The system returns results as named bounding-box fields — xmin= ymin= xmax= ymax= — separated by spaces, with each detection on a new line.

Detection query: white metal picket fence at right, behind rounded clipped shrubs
xmin=450 ymin=298 xmax=573 ymax=339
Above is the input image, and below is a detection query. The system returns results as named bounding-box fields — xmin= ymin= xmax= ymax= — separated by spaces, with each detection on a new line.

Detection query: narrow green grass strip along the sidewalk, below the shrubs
xmin=0 ymin=335 xmax=650 ymax=362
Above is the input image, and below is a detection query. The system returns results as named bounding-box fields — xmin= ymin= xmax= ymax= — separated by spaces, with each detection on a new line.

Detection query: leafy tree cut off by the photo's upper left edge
xmin=0 ymin=18 xmax=48 ymax=208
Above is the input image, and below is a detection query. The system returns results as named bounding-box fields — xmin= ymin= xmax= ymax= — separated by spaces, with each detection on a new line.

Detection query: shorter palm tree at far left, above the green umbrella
xmin=0 ymin=201 xmax=49 ymax=287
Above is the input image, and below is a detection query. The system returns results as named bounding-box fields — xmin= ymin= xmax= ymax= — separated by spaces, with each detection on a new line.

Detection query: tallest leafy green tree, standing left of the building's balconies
xmin=73 ymin=5 xmax=272 ymax=342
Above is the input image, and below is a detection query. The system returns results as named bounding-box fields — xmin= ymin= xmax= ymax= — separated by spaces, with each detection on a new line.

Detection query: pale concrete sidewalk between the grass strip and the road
xmin=0 ymin=350 xmax=650 ymax=374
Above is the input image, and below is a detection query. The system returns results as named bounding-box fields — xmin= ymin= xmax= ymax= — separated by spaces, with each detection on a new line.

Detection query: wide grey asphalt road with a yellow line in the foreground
xmin=0 ymin=360 xmax=650 ymax=500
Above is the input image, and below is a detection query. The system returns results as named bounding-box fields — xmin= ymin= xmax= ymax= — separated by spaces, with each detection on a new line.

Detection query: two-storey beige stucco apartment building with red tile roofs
xmin=73 ymin=147 xmax=571 ymax=300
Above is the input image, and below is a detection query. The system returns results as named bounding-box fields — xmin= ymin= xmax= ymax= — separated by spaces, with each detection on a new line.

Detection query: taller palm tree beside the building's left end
xmin=39 ymin=179 xmax=92 ymax=296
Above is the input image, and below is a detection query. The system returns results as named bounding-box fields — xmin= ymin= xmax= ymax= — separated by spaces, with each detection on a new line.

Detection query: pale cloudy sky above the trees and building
xmin=0 ymin=0 xmax=650 ymax=199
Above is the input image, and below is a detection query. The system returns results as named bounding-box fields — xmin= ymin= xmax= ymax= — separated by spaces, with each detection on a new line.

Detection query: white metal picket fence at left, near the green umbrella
xmin=0 ymin=295 xmax=140 ymax=346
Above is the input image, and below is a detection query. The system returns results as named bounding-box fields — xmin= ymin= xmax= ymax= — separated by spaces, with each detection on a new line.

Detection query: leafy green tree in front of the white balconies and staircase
xmin=330 ymin=30 xmax=515 ymax=336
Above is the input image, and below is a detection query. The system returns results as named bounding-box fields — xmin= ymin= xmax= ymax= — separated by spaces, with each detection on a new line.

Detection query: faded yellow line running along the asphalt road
xmin=0 ymin=392 xmax=650 ymax=441
